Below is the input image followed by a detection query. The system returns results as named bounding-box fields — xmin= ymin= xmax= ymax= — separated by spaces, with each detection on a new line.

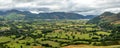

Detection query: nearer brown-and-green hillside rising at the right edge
xmin=88 ymin=12 xmax=120 ymax=24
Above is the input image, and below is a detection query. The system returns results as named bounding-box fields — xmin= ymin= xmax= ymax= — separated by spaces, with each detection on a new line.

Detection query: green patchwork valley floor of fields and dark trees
xmin=0 ymin=20 xmax=120 ymax=48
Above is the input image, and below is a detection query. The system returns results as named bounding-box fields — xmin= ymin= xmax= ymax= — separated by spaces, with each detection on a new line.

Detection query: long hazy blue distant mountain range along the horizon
xmin=0 ymin=10 xmax=95 ymax=19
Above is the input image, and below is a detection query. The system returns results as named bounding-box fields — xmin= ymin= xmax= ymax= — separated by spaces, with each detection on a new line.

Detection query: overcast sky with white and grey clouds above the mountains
xmin=0 ymin=0 xmax=120 ymax=15
